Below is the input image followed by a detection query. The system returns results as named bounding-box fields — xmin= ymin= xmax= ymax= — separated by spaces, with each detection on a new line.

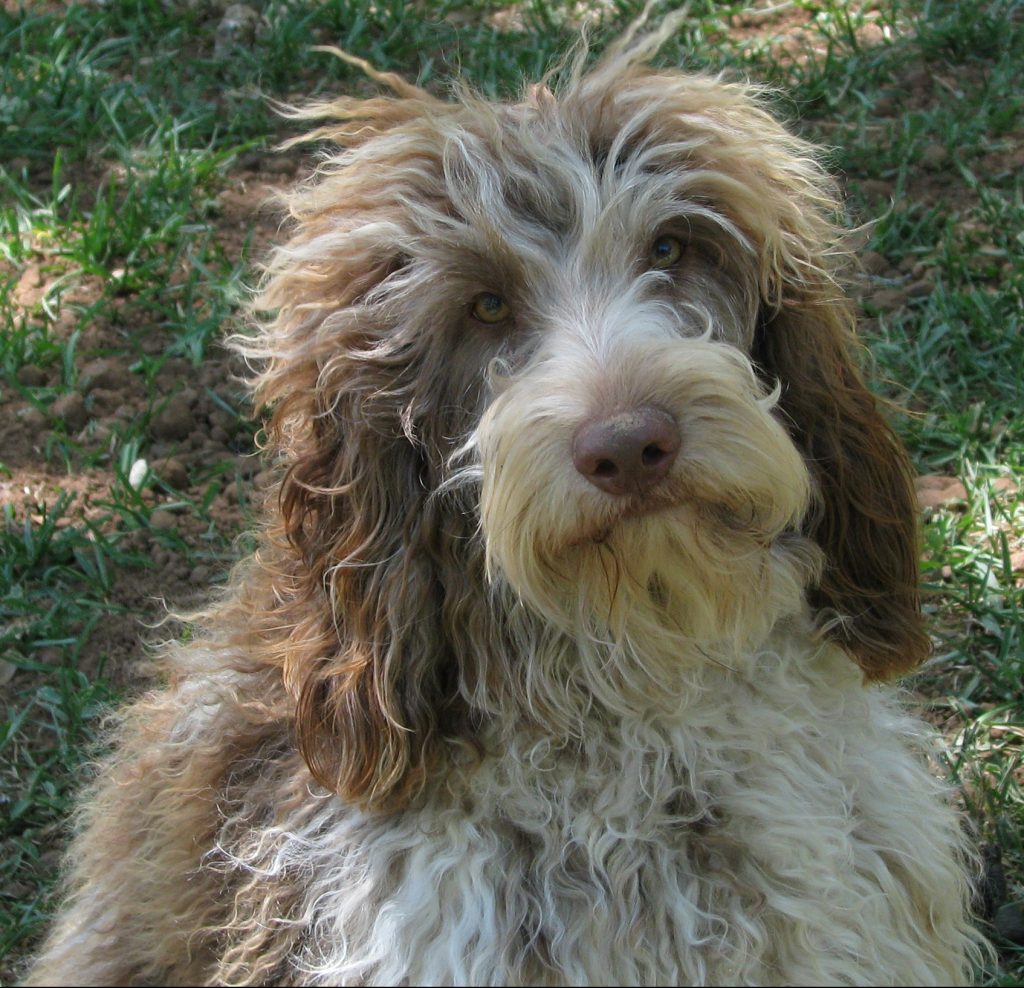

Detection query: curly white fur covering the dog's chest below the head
xmin=214 ymin=643 xmax=966 ymax=985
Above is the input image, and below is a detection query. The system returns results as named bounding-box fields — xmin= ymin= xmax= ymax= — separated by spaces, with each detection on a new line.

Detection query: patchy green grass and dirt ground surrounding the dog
xmin=0 ymin=0 xmax=1024 ymax=984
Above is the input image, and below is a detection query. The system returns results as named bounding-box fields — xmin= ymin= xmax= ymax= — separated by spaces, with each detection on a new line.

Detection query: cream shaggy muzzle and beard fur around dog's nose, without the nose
xmin=475 ymin=341 xmax=814 ymax=652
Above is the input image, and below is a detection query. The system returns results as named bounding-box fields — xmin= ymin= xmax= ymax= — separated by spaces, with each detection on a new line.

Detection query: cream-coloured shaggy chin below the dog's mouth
xmin=492 ymin=491 xmax=814 ymax=648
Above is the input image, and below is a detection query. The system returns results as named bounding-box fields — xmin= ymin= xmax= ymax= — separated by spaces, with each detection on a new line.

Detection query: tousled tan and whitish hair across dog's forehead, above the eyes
xmin=307 ymin=68 xmax=834 ymax=309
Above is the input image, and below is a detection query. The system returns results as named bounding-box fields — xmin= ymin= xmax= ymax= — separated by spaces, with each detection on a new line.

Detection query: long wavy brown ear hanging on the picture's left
xmin=281 ymin=407 xmax=471 ymax=807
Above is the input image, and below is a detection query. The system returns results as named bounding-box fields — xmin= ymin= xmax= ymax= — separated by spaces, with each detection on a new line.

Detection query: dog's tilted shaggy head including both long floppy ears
xmin=241 ymin=28 xmax=927 ymax=804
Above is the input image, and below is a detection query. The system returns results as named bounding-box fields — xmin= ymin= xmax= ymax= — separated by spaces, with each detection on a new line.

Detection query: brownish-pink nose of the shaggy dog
xmin=572 ymin=404 xmax=680 ymax=495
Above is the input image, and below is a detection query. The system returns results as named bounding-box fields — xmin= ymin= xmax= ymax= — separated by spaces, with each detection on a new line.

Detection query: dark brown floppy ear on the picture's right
xmin=754 ymin=290 xmax=930 ymax=679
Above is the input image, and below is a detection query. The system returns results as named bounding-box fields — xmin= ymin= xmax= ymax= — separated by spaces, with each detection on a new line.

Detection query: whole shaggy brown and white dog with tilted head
xmin=25 ymin=17 xmax=980 ymax=985
